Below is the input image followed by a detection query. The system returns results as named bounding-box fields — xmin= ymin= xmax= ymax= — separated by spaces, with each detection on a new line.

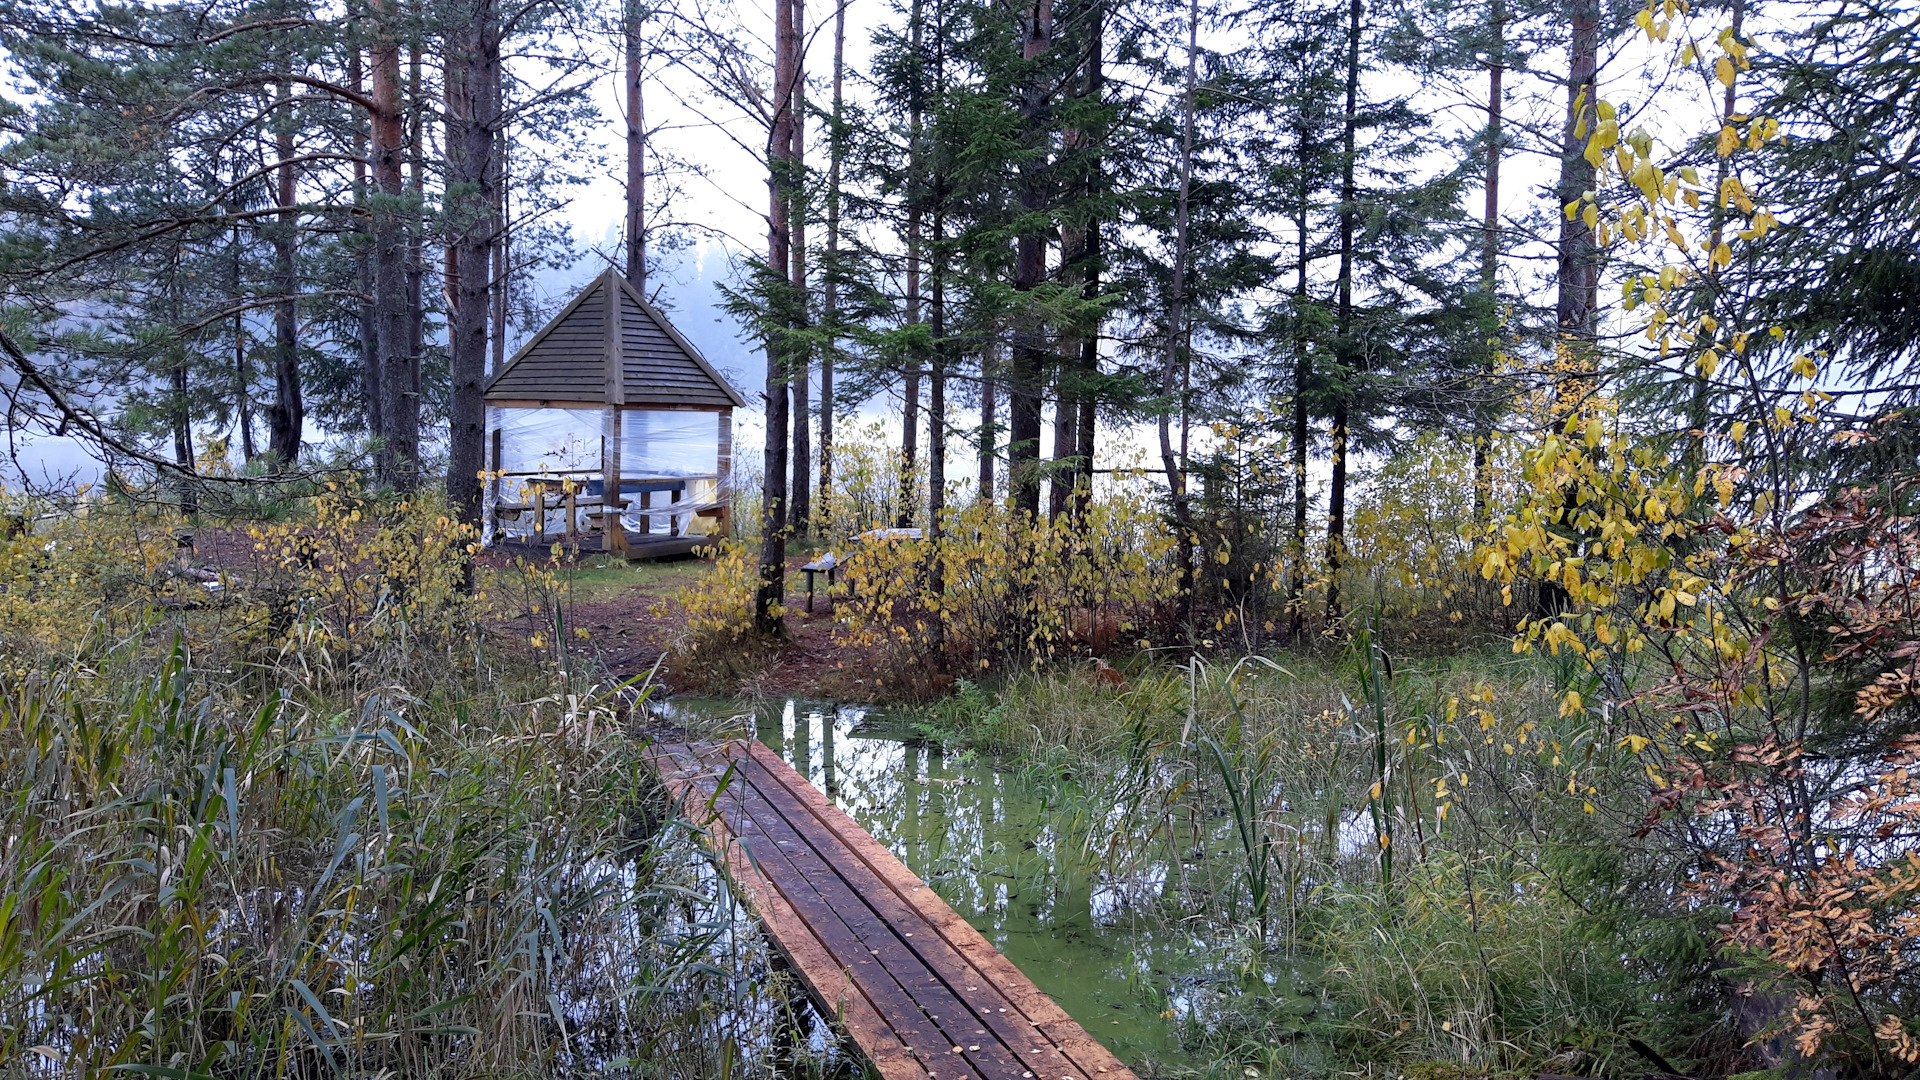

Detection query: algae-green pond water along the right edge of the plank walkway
xmin=670 ymin=698 xmax=1320 ymax=1065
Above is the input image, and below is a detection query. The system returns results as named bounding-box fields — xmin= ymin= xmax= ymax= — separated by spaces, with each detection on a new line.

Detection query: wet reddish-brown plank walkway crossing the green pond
xmin=651 ymin=742 xmax=1135 ymax=1080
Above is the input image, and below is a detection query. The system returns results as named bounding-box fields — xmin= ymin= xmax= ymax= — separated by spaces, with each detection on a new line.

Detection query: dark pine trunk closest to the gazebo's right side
xmin=753 ymin=0 xmax=799 ymax=634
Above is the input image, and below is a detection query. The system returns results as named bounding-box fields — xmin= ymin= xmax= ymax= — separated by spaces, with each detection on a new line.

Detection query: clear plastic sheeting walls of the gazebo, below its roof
xmin=486 ymin=409 xmax=726 ymax=544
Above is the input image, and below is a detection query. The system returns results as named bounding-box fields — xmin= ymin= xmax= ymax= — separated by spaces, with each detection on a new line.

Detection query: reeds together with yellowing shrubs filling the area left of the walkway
xmin=0 ymin=496 xmax=847 ymax=1080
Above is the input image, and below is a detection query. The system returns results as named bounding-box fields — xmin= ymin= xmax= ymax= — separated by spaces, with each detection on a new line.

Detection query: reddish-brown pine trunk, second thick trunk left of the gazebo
xmin=369 ymin=0 xmax=420 ymax=492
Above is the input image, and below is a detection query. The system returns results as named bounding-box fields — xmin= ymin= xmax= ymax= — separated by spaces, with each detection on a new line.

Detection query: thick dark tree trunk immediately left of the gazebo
xmin=444 ymin=0 xmax=501 ymax=527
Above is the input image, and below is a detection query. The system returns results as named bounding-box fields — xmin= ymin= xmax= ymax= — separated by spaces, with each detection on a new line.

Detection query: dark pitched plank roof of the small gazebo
xmin=486 ymin=269 xmax=747 ymax=409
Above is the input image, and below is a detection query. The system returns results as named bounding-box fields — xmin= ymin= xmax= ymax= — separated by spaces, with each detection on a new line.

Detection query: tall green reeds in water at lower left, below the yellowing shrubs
xmin=0 ymin=634 xmax=756 ymax=1076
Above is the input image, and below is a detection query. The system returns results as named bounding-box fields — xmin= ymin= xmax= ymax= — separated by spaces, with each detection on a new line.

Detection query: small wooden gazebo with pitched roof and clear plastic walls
xmin=486 ymin=271 xmax=747 ymax=557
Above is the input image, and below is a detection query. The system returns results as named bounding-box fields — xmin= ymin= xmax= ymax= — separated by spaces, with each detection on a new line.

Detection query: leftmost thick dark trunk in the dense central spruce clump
xmin=1006 ymin=0 xmax=1054 ymax=517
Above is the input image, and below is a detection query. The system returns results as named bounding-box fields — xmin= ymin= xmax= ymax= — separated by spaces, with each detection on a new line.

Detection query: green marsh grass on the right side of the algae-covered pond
xmin=906 ymin=636 xmax=1715 ymax=1076
